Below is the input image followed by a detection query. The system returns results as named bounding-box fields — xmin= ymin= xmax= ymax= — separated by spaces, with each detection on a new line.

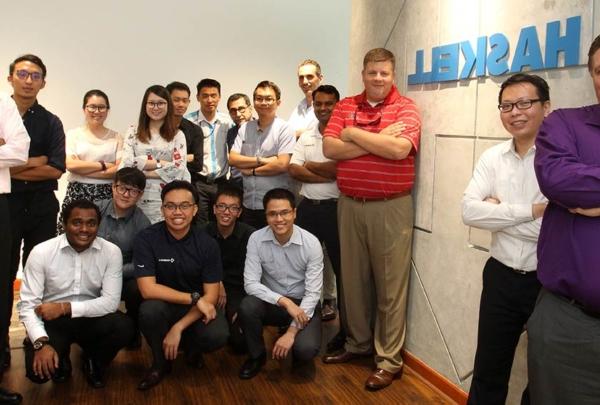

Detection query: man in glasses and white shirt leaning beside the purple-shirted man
xmin=462 ymin=73 xmax=550 ymax=405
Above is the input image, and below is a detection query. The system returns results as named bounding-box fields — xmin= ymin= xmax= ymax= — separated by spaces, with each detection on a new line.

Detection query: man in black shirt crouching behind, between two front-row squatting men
xmin=205 ymin=185 xmax=254 ymax=353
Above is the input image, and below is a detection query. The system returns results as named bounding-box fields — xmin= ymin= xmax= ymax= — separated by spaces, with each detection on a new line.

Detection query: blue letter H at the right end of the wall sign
xmin=546 ymin=16 xmax=581 ymax=69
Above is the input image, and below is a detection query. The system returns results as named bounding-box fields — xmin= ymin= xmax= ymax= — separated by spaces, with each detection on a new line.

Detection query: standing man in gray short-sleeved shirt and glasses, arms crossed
xmin=229 ymin=81 xmax=296 ymax=229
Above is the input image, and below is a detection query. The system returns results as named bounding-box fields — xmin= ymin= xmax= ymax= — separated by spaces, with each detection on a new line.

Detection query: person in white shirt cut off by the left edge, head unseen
xmin=0 ymin=94 xmax=30 ymax=404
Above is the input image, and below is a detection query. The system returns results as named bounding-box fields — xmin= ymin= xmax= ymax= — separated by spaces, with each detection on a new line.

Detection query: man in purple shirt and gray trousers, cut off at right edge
xmin=528 ymin=36 xmax=600 ymax=405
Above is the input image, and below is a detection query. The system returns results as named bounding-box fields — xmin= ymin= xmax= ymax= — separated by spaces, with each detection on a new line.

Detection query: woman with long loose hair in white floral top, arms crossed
xmin=119 ymin=85 xmax=190 ymax=223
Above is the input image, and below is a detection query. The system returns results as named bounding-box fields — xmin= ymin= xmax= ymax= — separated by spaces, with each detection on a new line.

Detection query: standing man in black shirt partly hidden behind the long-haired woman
xmin=167 ymin=82 xmax=204 ymax=181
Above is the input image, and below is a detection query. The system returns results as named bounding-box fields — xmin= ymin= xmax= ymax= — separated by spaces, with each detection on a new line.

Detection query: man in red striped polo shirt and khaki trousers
xmin=323 ymin=48 xmax=421 ymax=390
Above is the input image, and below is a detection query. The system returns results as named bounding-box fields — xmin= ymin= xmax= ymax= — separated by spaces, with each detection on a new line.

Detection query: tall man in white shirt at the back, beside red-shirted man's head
xmin=288 ymin=59 xmax=323 ymax=138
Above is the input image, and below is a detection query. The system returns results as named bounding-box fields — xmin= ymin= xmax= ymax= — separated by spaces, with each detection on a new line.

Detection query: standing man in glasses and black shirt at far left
xmin=0 ymin=55 xmax=65 ymax=367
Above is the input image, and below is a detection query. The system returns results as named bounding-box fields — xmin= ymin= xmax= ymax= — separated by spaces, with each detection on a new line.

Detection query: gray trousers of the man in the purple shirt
xmin=527 ymin=288 xmax=600 ymax=405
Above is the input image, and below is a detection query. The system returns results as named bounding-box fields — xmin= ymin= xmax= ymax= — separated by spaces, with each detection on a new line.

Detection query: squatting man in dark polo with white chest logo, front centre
xmin=133 ymin=180 xmax=228 ymax=390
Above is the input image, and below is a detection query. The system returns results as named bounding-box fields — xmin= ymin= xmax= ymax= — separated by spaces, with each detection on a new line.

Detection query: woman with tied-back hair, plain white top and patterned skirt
xmin=58 ymin=89 xmax=123 ymax=233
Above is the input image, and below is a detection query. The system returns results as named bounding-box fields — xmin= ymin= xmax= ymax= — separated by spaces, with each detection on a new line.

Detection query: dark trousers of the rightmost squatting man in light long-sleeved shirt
xmin=239 ymin=295 xmax=321 ymax=361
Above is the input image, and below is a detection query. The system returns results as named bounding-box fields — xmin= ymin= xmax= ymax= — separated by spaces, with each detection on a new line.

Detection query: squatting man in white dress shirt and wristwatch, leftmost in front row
xmin=19 ymin=200 xmax=134 ymax=388
